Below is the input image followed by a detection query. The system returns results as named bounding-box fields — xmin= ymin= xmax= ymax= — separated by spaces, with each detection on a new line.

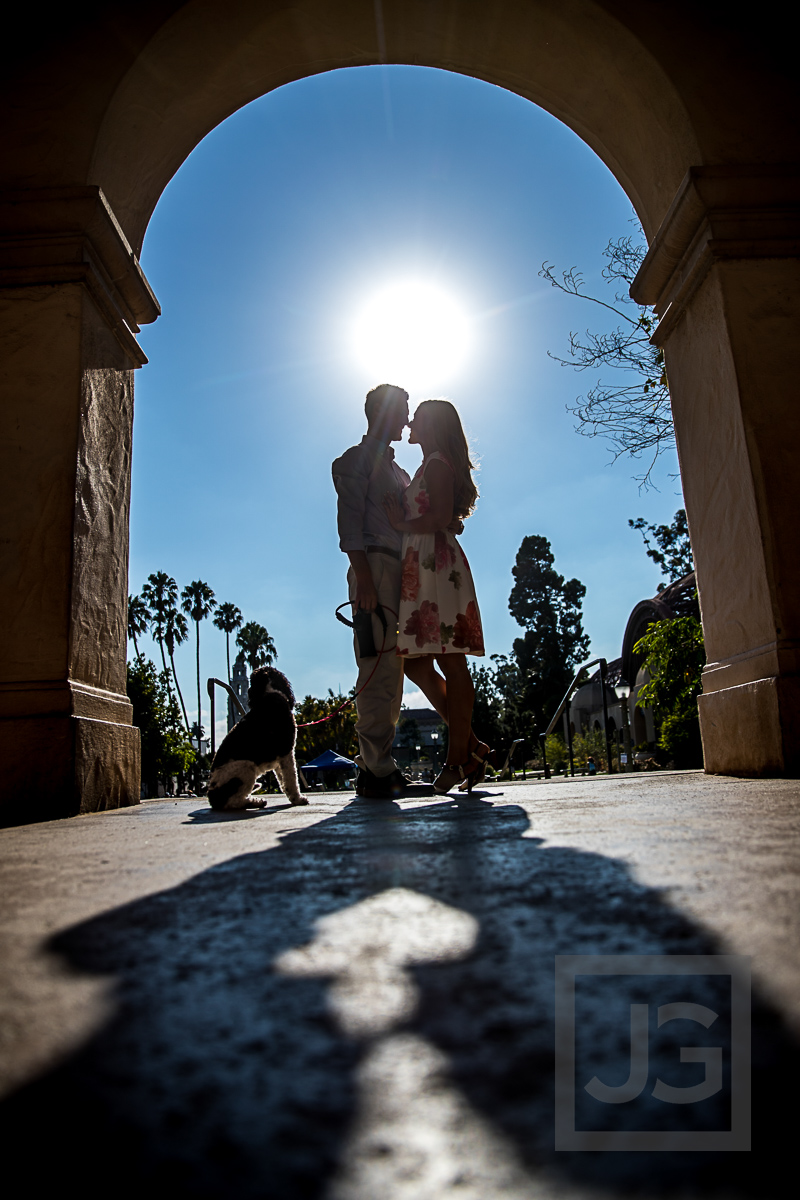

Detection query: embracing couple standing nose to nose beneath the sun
xmin=333 ymin=384 xmax=489 ymax=799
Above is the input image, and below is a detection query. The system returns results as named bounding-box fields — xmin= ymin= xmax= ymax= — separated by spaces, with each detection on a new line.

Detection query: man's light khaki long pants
xmin=348 ymin=554 xmax=403 ymax=779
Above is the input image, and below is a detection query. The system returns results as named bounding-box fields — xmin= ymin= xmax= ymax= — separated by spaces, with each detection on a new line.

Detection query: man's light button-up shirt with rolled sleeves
xmin=332 ymin=433 xmax=410 ymax=553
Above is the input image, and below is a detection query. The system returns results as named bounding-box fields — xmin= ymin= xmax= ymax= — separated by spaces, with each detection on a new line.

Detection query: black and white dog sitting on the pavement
xmin=207 ymin=667 xmax=308 ymax=811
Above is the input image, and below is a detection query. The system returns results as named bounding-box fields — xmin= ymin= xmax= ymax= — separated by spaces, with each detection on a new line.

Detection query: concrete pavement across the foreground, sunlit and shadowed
xmin=0 ymin=773 xmax=800 ymax=1200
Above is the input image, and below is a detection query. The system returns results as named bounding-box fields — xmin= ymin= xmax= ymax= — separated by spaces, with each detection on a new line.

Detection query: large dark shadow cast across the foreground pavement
xmin=0 ymin=798 xmax=799 ymax=1200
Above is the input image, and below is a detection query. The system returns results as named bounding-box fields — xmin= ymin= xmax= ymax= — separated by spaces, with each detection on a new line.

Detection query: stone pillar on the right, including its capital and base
xmin=631 ymin=166 xmax=800 ymax=775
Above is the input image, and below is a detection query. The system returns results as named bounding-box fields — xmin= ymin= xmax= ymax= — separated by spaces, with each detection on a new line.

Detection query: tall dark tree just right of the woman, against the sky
xmin=503 ymin=535 xmax=589 ymax=742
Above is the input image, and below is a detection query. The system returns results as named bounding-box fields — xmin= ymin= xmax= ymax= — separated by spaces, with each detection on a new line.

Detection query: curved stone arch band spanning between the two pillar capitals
xmin=86 ymin=0 xmax=702 ymax=247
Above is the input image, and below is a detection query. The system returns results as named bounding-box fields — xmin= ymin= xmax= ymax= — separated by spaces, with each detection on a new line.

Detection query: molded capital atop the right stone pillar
xmin=631 ymin=163 xmax=800 ymax=346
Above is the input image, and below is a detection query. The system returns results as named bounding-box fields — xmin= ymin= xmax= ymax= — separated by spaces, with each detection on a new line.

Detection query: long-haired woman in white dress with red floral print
xmin=384 ymin=400 xmax=491 ymax=794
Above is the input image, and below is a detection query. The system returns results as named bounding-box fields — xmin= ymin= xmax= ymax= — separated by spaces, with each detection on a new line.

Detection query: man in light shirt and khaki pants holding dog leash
xmin=332 ymin=383 xmax=410 ymax=799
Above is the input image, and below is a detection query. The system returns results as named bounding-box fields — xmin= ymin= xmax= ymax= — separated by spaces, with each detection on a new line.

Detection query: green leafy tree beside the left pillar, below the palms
xmin=127 ymin=654 xmax=194 ymax=794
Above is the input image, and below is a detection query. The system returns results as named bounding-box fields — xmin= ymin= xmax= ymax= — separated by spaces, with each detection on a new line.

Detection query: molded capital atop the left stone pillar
xmin=0 ymin=186 xmax=161 ymax=365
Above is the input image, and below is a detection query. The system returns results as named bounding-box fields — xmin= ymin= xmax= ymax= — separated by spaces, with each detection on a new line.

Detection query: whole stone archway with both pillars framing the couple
xmin=0 ymin=0 xmax=800 ymax=820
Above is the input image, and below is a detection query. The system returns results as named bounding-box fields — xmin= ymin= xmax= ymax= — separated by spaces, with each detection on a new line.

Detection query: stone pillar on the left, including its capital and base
xmin=0 ymin=187 xmax=158 ymax=824
